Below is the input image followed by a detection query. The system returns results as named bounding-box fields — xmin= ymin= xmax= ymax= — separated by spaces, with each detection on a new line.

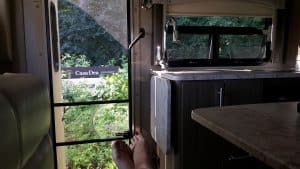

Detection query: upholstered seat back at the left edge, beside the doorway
xmin=0 ymin=74 xmax=53 ymax=169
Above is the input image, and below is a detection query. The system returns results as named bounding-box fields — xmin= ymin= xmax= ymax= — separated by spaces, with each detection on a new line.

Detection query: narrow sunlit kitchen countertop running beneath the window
xmin=152 ymin=65 xmax=300 ymax=80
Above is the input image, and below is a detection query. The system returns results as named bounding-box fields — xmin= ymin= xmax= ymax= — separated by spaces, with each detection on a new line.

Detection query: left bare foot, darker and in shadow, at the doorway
xmin=112 ymin=141 xmax=134 ymax=169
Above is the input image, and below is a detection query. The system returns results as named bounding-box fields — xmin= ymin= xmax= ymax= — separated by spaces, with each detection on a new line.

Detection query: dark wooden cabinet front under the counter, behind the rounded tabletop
xmin=172 ymin=80 xmax=263 ymax=169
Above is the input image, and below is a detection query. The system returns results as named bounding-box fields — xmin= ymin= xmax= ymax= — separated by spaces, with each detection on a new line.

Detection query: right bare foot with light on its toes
xmin=130 ymin=134 xmax=154 ymax=169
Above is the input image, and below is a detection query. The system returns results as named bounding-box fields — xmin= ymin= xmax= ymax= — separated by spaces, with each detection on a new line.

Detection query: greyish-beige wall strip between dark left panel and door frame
xmin=23 ymin=0 xmax=49 ymax=84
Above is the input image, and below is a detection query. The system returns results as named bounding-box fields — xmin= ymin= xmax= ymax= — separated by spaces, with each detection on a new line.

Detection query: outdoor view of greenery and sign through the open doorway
xmin=53 ymin=0 xmax=130 ymax=169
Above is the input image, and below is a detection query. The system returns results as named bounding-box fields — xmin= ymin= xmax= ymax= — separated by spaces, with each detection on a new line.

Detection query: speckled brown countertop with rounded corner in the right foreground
xmin=192 ymin=102 xmax=300 ymax=169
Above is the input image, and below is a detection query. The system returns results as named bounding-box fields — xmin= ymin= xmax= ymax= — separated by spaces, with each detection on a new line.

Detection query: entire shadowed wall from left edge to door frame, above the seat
xmin=0 ymin=0 xmax=48 ymax=80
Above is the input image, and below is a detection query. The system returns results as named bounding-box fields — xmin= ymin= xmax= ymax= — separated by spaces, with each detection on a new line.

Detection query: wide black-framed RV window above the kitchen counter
xmin=165 ymin=16 xmax=271 ymax=66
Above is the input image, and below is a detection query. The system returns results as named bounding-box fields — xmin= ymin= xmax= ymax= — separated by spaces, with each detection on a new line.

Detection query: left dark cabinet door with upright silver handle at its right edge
xmin=172 ymin=80 xmax=224 ymax=169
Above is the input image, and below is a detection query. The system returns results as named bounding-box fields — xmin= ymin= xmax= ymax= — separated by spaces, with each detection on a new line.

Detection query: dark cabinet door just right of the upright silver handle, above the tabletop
xmin=223 ymin=79 xmax=263 ymax=106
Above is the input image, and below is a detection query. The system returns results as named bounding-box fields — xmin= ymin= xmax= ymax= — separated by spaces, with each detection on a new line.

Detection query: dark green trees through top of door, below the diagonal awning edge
xmin=58 ymin=0 xmax=126 ymax=66
